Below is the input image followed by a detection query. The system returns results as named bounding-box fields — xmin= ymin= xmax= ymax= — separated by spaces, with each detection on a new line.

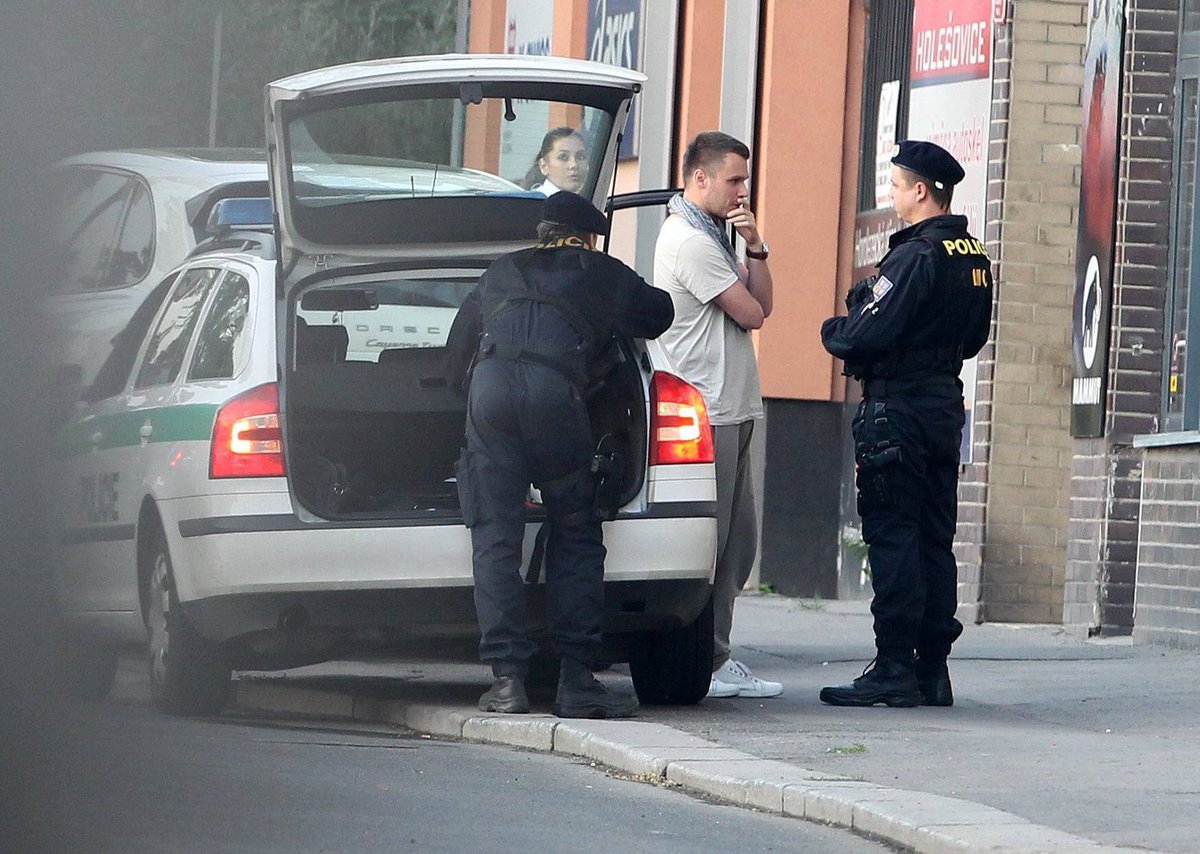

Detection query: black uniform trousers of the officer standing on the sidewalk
xmin=852 ymin=374 xmax=964 ymax=662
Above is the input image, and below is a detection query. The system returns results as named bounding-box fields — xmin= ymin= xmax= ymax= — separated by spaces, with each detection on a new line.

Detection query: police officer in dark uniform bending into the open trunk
xmin=448 ymin=191 xmax=674 ymax=717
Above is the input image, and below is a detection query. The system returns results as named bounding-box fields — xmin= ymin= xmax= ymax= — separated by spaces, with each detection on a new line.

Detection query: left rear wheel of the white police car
xmin=146 ymin=530 xmax=233 ymax=715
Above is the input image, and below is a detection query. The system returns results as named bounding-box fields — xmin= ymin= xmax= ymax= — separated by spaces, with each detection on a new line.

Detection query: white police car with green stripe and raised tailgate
xmin=49 ymin=55 xmax=716 ymax=714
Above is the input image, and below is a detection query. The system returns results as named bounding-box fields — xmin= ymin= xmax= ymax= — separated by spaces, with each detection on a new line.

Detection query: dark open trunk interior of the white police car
xmin=282 ymin=271 xmax=647 ymax=524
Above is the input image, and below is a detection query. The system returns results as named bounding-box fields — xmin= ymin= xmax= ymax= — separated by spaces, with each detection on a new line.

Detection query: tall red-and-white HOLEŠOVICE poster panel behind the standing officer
xmin=908 ymin=0 xmax=996 ymax=463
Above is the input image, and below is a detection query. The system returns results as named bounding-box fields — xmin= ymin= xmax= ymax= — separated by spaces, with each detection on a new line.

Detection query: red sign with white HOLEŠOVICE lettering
xmin=912 ymin=0 xmax=995 ymax=86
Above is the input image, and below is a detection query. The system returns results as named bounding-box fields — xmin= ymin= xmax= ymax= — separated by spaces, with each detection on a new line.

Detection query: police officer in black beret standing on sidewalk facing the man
xmin=821 ymin=140 xmax=992 ymax=706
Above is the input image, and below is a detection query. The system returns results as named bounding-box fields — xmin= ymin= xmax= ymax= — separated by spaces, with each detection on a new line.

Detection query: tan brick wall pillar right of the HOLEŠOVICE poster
xmin=982 ymin=0 xmax=1087 ymax=623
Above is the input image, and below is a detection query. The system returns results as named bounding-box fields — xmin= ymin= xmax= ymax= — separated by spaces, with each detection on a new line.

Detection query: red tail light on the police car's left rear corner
xmin=209 ymin=383 xmax=284 ymax=477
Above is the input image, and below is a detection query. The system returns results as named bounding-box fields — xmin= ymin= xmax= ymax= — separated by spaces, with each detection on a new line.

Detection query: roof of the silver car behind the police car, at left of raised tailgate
xmin=59 ymin=149 xmax=266 ymax=185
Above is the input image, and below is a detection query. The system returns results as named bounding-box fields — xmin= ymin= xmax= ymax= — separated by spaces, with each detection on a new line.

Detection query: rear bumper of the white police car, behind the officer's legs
xmin=161 ymin=499 xmax=716 ymax=641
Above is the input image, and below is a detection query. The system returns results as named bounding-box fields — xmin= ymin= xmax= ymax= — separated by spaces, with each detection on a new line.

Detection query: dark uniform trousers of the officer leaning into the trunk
xmin=458 ymin=359 xmax=605 ymax=676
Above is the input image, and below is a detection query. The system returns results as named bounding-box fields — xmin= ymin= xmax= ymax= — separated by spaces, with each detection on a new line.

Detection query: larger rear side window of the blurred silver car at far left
xmin=56 ymin=170 xmax=136 ymax=293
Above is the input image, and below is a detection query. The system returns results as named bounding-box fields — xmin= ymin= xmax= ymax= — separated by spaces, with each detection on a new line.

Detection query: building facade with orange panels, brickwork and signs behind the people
xmin=468 ymin=0 xmax=1200 ymax=648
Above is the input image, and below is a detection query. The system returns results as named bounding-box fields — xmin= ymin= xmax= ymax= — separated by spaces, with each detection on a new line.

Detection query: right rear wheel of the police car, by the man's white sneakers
xmin=629 ymin=597 xmax=713 ymax=705
